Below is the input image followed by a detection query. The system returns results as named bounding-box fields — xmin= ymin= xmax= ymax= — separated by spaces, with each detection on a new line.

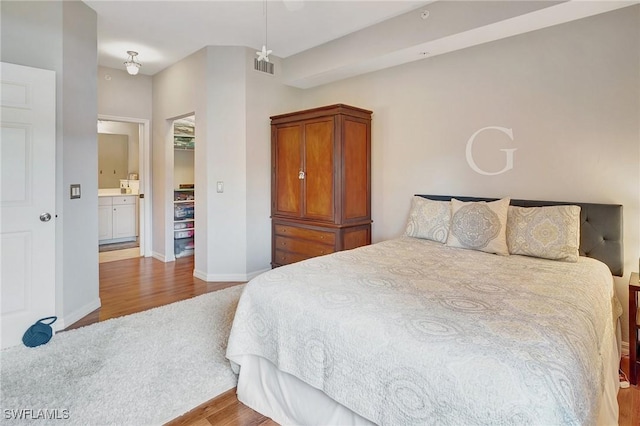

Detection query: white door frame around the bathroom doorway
xmin=98 ymin=114 xmax=153 ymax=257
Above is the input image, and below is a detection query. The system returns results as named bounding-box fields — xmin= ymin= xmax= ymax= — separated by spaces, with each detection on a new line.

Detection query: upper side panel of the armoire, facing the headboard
xmin=342 ymin=119 xmax=370 ymax=220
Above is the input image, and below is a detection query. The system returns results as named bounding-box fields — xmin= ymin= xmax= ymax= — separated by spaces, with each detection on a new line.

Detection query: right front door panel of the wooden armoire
xmin=304 ymin=119 xmax=334 ymax=221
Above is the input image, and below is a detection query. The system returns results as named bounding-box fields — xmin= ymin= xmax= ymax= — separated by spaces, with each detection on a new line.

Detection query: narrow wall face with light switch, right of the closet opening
xmin=201 ymin=46 xmax=247 ymax=281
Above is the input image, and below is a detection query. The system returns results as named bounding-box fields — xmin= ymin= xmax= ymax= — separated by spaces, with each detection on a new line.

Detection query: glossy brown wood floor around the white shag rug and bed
xmin=67 ymin=257 xmax=640 ymax=426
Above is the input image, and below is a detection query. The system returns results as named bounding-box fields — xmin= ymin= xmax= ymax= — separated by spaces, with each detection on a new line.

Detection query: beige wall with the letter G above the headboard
xmin=304 ymin=6 xmax=640 ymax=339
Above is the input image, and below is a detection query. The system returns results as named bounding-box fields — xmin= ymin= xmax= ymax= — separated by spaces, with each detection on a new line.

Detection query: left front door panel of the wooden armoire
xmin=274 ymin=126 xmax=302 ymax=216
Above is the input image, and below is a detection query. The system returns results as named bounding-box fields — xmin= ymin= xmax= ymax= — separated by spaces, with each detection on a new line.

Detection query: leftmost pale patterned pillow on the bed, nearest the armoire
xmin=404 ymin=196 xmax=451 ymax=243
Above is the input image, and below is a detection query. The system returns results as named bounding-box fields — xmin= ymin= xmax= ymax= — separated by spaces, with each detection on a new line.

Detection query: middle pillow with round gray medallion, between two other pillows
xmin=447 ymin=198 xmax=511 ymax=256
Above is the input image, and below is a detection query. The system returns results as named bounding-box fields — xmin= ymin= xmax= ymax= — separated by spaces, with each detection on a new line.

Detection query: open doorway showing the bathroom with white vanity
xmin=97 ymin=115 xmax=151 ymax=263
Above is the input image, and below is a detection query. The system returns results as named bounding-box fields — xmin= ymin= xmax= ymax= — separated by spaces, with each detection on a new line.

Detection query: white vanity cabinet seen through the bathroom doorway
xmin=98 ymin=195 xmax=138 ymax=244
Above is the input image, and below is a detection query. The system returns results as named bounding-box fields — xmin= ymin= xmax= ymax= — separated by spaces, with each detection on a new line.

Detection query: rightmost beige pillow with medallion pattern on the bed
xmin=507 ymin=206 xmax=580 ymax=262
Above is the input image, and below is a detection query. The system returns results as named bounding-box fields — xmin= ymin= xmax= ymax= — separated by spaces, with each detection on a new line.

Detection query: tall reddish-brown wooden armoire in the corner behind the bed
xmin=271 ymin=104 xmax=371 ymax=268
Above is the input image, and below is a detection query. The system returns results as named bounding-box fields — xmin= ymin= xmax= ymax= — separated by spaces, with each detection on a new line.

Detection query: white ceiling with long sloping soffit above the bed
xmin=84 ymin=0 xmax=638 ymax=88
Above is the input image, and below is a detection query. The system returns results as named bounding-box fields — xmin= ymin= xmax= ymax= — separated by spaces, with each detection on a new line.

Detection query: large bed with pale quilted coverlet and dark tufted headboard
xmin=227 ymin=195 xmax=623 ymax=425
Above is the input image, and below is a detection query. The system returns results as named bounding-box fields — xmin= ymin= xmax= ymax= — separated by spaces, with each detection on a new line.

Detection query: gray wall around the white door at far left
xmin=0 ymin=1 xmax=100 ymax=328
